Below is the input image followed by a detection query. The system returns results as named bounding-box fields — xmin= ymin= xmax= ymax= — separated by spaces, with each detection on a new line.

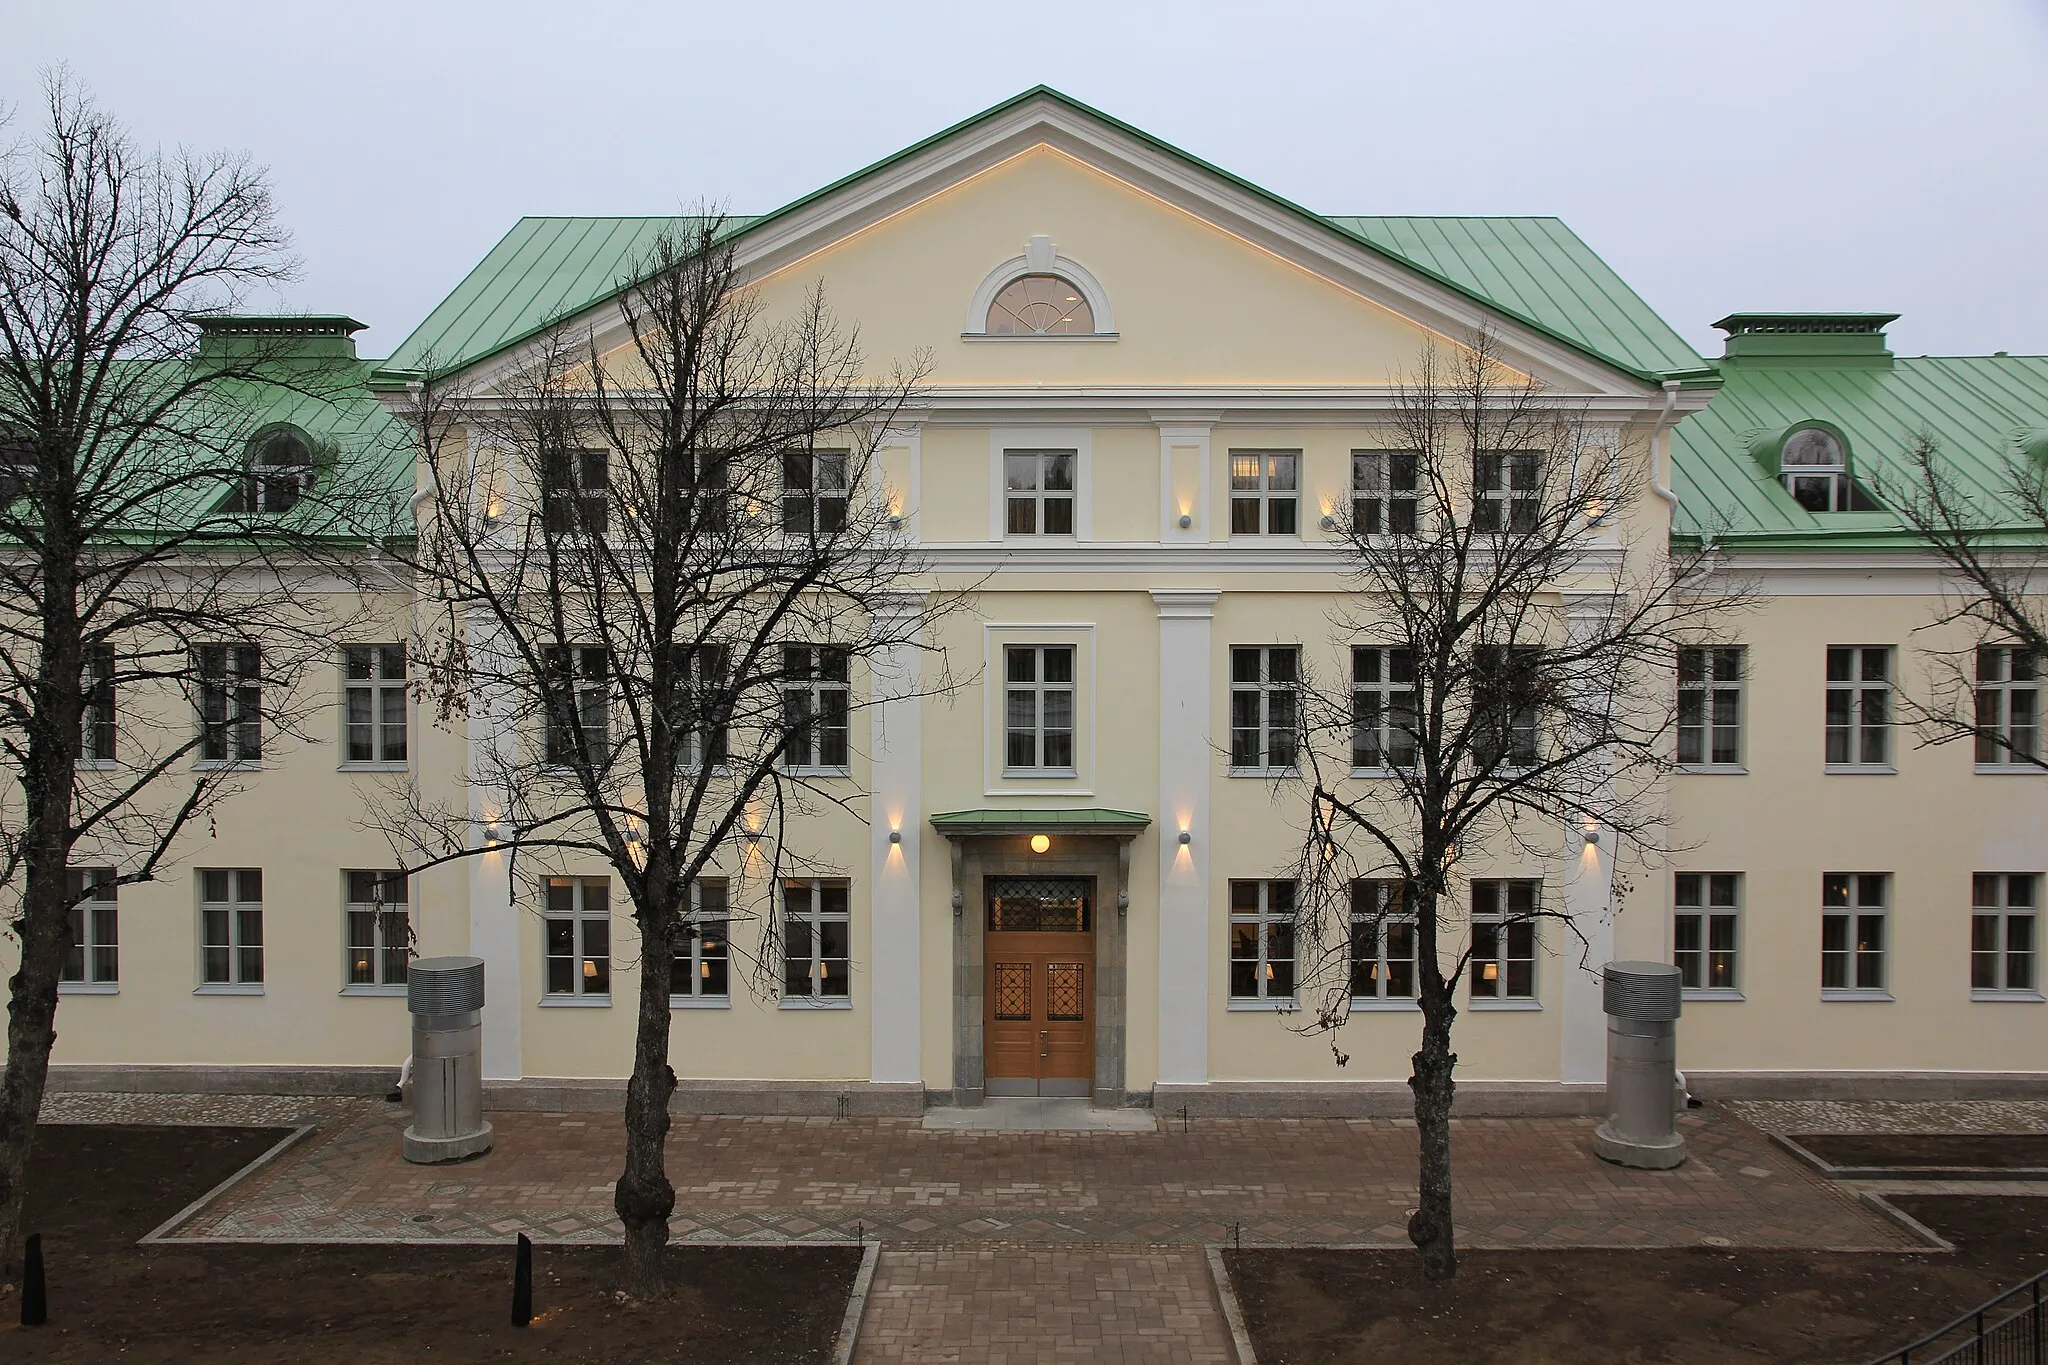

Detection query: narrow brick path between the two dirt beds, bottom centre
xmin=854 ymin=1246 xmax=1235 ymax=1365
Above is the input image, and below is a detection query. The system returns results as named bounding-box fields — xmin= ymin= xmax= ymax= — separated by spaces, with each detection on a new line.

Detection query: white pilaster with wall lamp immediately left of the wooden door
xmin=868 ymin=593 xmax=924 ymax=1085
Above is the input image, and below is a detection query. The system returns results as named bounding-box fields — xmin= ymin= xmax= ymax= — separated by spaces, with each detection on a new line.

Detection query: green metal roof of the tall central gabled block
xmin=383 ymin=86 xmax=1712 ymax=383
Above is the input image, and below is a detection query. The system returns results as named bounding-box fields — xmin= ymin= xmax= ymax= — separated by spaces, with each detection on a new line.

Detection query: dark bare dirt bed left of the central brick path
xmin=0 ymin=1126 xmax=860 ymax=1365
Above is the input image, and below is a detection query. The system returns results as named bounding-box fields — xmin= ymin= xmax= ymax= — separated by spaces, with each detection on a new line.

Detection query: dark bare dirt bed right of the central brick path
xmin=1227 ymin=1197 xmax=2048 ymax=1365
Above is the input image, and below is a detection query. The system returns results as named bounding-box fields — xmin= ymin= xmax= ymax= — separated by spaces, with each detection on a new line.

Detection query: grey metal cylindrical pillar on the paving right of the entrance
xmin=1593 ymin=962 xmax=1686 ymax=1171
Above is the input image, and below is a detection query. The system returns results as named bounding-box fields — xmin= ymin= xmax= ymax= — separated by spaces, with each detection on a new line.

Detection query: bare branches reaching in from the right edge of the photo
xmin=1878 ymin=432 xmax=2048 ymax=767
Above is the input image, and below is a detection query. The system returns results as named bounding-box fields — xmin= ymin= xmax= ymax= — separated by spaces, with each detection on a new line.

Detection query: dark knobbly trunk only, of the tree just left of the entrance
xmin=612 ymin=896 xmax=676 ymax=1300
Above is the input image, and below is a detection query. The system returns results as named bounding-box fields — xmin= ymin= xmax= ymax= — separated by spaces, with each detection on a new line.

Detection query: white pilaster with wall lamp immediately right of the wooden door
xmin=1153 ymin=587 xmax=1221 ymax=1085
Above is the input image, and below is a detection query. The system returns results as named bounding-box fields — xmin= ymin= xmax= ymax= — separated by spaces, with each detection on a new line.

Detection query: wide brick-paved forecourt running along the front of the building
xmin=155 ymin=1101 xmax=1911 ymax=1250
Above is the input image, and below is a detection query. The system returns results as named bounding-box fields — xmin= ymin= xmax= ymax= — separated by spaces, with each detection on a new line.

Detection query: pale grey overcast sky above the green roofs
xmin=0 ymin=0 xmax=2048 ymax=354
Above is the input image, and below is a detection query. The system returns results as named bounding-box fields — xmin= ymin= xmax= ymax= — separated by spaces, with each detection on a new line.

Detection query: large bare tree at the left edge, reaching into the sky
xmin=0 ymin=72 xmax=387 ymax=1259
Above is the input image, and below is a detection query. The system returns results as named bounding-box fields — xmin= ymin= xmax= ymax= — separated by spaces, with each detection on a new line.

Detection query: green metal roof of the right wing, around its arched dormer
xmin=1671 ymin=356 xmax=2048 ymax=551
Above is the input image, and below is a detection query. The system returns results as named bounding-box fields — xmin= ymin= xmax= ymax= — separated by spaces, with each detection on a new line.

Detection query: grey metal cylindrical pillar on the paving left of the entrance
xmin=403 ymin=958 xmax=492 ymax=1164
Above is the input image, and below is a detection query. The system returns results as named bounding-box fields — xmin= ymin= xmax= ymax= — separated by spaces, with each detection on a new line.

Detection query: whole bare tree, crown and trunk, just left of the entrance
xmin=387 ymin=215 xmax=940 ymax=1297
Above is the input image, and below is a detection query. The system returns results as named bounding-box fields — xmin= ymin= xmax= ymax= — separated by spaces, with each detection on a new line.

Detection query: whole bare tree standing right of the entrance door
xmin=1292 ymin=334 xmax=1731 ymax=1279
